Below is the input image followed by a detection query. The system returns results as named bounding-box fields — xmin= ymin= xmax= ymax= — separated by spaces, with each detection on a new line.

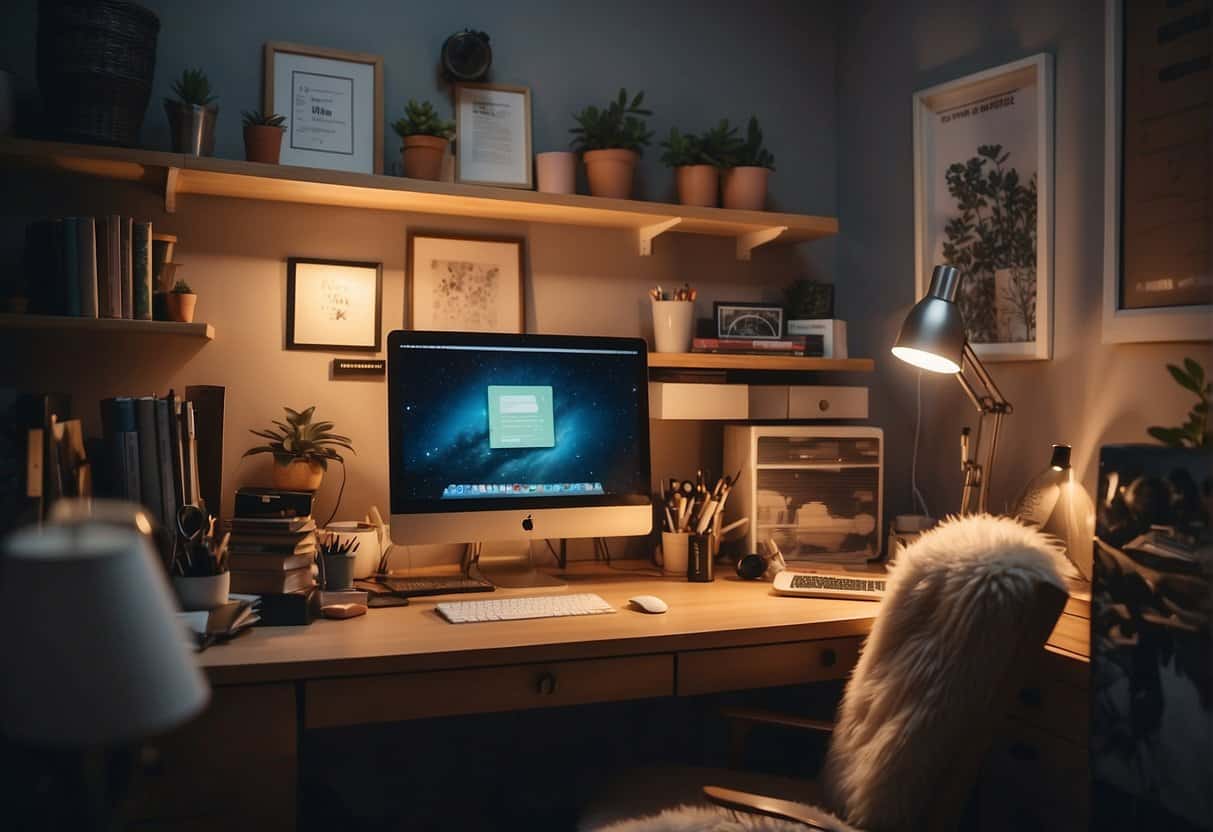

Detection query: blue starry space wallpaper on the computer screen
xmin=393 ymin=349 xmax=649 ymax=500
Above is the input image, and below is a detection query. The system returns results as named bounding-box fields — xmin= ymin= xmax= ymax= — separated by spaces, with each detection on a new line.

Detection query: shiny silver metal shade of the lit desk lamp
xmin=893 ymin=266 xmax=964 ymax=372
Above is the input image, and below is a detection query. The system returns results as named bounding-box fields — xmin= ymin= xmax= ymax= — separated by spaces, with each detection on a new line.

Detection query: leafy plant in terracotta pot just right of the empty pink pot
xmin=569 ymin=89 xmax=653 ymax=199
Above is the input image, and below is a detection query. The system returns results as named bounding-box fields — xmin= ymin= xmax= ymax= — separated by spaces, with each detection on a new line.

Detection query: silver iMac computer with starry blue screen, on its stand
xmin=388 ymin=331 xmax=653 ymax=587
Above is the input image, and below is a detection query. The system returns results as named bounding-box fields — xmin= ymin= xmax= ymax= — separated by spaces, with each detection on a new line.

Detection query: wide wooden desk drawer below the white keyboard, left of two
xmin=304 ymin=654 xmax=674 ymax=728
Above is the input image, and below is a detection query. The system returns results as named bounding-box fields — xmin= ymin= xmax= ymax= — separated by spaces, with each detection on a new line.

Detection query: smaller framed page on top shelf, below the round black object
xmin=455 ymin=84 xmax=533 ymax=188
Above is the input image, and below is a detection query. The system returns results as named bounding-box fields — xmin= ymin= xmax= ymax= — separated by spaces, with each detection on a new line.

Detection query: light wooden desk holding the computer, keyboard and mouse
xmin=127 ymin=563 xmax=1089 ymax=828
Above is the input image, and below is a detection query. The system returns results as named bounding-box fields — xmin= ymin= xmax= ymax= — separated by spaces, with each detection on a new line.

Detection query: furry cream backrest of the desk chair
xmin=824 ymin=515 xmax=1067 ymax=832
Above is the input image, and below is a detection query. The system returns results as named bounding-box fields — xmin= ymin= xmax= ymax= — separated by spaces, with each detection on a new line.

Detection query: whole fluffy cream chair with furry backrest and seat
xmin=581 ymin=515 xmax=1067 ymax=832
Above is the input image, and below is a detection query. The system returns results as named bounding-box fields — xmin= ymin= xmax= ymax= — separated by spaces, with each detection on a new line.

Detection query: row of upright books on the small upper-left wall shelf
xmin=24 ymin=213 xmax=163 ymax=320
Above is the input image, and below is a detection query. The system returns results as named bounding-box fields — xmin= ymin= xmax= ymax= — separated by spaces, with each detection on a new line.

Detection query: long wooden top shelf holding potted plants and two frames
xmin=0 ymin=139 xmax=838 ymax=260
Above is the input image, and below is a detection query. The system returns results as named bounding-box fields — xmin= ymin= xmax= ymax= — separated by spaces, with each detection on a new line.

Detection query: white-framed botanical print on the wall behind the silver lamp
xmin=913 ymin=53 xmax=1053 ymax=360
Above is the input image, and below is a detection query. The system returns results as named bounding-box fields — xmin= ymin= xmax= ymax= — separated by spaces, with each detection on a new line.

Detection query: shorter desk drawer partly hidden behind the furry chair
xmin=678 ymin=637 xmax=862 ymax=696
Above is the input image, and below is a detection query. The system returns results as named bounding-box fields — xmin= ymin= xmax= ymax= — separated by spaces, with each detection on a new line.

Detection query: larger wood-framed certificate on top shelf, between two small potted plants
xmin=262 ymin=41 xmax=383 ymax=173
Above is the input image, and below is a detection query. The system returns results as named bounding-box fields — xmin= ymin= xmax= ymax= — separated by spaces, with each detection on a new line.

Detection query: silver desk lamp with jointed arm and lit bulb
xmin=893 ymin=266 xmax=1010 ymax=514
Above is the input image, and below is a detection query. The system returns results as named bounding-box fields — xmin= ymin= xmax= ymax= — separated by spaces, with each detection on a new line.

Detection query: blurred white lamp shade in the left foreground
xmin=0 ymin=523 xmax=210 ymax=746
